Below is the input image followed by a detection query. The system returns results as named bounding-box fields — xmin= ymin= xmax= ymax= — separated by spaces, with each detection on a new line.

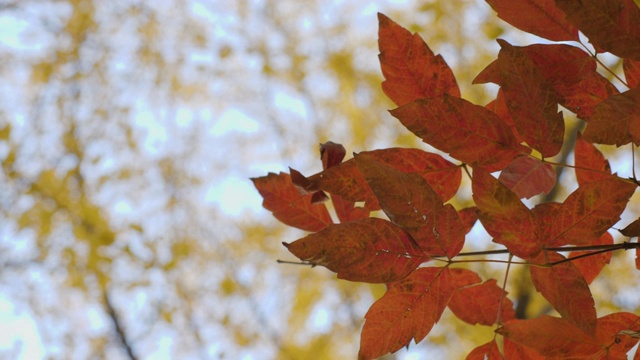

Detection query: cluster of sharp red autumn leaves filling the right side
xmin=253 ymin=0 xmax=640 ymax=359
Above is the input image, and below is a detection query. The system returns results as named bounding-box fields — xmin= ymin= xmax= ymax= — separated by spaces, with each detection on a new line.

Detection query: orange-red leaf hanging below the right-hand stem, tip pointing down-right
xmin=530 ymin=251 xmax=597 ymax=336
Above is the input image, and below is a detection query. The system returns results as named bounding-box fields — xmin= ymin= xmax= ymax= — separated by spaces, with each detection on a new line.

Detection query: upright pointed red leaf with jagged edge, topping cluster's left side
xmin=378 ymin=13 xmax=460 ymax=106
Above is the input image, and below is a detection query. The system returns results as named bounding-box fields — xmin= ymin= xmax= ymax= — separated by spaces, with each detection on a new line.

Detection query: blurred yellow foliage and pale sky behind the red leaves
xmin=0 ymin=0 xmax=638 ymax=359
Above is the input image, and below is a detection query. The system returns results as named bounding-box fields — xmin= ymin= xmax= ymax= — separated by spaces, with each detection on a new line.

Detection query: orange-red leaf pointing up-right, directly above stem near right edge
xmin=548 ymin=178 xmax=636 ymax=246
